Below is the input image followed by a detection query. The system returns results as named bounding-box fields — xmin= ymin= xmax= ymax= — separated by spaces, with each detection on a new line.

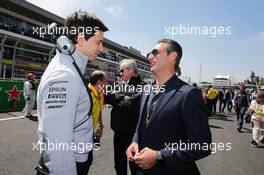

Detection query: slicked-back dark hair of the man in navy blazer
xmin=158 ymin=39 xmax=182 ymax=70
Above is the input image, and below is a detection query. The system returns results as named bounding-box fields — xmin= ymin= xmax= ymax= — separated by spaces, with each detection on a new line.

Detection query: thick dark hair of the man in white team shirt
xmin=64 ymin=10 xmax=108 ymax=44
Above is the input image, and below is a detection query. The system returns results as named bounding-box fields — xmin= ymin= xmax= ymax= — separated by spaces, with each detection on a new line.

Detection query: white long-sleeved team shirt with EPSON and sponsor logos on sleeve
xmin=37 ymin=50 xmax=93 ymax=175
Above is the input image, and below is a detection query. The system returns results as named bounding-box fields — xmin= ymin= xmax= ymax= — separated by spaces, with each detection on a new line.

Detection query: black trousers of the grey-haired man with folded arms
xmin=114 ymin=132 xmax=136 ymax=175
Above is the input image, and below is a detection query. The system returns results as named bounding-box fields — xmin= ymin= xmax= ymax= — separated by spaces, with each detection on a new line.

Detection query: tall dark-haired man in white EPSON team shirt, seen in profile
xmin=37 ymin=11 xmax=108 ymax=175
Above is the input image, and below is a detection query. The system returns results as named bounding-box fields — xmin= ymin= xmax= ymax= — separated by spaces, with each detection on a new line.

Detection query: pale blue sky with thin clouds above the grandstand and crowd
xmin=28 ymin=0 xmax=264 ymax=81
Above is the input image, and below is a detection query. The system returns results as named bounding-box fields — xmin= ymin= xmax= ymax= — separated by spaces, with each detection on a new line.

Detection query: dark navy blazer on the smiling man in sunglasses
xmin=133 ymin=75 xmax=211 ymax=175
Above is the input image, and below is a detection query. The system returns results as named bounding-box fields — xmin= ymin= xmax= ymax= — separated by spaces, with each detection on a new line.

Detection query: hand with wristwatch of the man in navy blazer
xmin=135 ymin=147 xmax=157 ymax=169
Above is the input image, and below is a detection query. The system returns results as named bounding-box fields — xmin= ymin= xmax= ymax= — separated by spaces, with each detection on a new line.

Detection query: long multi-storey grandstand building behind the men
xmin=0 ymin=0 xmax=151 ymax=81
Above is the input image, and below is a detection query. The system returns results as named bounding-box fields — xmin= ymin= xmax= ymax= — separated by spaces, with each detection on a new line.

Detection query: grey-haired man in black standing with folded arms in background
xmin=105 ymin=59 xmax=145 ymax=175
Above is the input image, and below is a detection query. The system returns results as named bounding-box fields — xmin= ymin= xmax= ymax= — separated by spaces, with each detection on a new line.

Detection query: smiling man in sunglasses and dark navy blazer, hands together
xmin=127 ymin=39 xmax=211 ymax=175
